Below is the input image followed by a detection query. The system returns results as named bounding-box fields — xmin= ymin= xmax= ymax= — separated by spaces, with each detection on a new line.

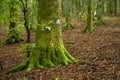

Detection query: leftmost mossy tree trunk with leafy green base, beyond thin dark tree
xmin=5 ymin=0 xmax=22 ymax=44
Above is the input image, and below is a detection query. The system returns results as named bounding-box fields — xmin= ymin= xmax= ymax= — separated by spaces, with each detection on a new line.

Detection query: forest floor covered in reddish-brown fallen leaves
xmin=0 ymin=18 xmax=120 ymax=80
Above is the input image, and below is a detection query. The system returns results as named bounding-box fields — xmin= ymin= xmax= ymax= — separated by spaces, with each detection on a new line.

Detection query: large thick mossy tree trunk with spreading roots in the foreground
xmin=6 ymin=0 xmax=76 ymax=73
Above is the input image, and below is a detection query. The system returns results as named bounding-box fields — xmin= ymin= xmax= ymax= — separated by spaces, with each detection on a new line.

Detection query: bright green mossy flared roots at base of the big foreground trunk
xmin=5 ymin=46 xmax=77 ymax=74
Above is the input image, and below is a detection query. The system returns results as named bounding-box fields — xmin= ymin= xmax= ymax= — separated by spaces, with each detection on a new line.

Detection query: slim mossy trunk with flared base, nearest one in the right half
xmin=84 ymin=0 xmax=95 ymax=33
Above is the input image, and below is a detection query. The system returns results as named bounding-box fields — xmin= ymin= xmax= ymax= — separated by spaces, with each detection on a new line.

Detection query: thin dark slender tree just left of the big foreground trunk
xmin=19 ymin=0 xmax=35 ymax=43
